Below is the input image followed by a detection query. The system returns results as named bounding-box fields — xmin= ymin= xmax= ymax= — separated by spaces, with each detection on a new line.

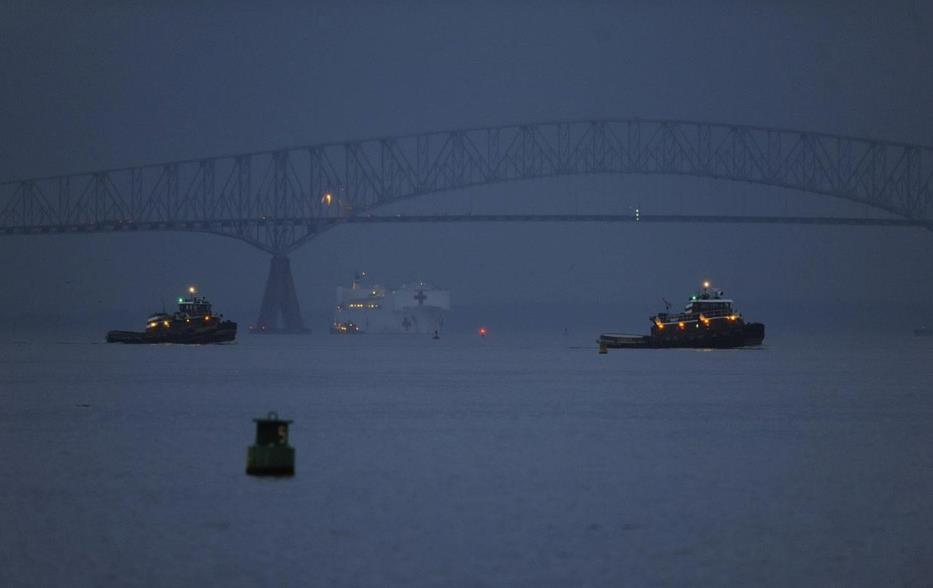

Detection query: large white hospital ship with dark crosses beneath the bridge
xmin=330 ymin=273 xmax=450 ymax=334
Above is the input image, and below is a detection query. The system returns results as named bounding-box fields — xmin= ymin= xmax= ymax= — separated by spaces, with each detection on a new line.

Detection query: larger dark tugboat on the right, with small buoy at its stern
xmin=596 ymin=282 xmax=765 ymax=353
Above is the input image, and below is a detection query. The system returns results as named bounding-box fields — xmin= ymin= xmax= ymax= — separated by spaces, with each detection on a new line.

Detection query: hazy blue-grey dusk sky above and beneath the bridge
xmin=0 ymin=1 xmax=933 ymax=326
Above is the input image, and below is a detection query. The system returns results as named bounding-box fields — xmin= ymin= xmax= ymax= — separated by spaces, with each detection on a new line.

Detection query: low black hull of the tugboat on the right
xmin=596 ymin=323 xmax=765 ymax=350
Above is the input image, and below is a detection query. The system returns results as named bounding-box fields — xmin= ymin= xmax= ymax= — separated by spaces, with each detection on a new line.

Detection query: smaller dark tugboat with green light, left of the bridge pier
xmin=107 ymin=286 xmax=236 ymax=343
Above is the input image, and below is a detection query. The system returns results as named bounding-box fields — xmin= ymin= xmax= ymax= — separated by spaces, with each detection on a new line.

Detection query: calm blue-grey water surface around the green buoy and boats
xmin=0 ymin=333 xmax=933 ymax=587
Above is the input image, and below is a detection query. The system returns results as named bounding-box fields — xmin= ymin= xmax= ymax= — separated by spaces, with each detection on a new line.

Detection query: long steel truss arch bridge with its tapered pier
xmin=0 ymin=119 xmax=933 ymax=331
